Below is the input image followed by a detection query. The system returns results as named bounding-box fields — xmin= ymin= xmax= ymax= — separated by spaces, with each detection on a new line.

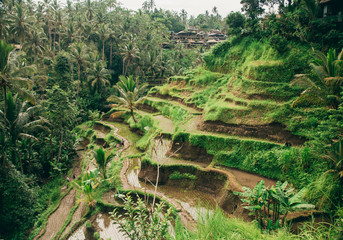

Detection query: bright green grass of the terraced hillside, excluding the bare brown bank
xmin=145 ymin=38 xmax=334 ymax=193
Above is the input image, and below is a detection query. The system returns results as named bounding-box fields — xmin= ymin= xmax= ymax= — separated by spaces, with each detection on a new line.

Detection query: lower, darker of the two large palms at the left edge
xmin=0 ymin=92 xmax=47 ymax=172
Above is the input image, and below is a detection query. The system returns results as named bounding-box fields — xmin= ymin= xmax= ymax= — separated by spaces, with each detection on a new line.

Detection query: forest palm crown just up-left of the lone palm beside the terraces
xmin=87 ymin=61 xmax=111 ymax=92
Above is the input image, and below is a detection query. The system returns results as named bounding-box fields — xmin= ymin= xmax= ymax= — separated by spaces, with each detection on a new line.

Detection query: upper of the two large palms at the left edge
xmin=0 ymin=40 xmax=35 ymax=117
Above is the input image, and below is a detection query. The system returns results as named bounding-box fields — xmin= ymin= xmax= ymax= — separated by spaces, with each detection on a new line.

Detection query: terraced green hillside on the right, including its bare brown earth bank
xmin=144 ymin=37 xmax=337 ymax=211
